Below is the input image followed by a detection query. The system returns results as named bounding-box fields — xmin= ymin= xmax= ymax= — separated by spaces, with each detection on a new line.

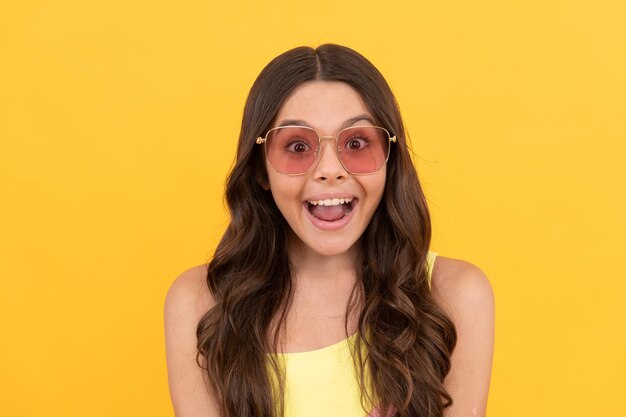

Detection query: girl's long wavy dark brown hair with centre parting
xmin=197 ymin=44 xmax=456 ymax=417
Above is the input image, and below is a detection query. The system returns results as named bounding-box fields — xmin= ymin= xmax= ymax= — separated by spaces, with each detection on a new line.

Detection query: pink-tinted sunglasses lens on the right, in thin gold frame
xmin=338 ymin=126 xmax=389 ymax=174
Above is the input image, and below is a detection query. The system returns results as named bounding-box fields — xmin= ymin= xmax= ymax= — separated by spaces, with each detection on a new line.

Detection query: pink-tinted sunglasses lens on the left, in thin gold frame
xmin=265 ymin=127 xmax=319 ymax=174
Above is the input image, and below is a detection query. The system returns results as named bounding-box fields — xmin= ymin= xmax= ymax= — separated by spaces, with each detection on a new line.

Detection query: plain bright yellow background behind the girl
xmin=0 ymin=0 xmax=626 ymax=417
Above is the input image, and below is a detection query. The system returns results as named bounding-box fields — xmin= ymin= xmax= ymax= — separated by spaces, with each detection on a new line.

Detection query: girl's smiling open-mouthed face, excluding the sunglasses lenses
xmin=265 ymin=81 xmax=386 ymax=256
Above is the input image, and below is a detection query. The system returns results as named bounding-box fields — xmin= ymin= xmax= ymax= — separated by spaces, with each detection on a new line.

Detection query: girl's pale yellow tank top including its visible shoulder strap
xmin=276 ymin=252 xmax=437 ymax=417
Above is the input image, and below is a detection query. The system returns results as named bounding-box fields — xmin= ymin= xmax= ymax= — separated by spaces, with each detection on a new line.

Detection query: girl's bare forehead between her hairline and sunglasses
xmin=274 ymin=81 xmax=374 ymax=132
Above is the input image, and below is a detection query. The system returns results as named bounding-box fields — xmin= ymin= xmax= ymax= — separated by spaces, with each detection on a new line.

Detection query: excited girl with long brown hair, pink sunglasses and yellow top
xmin=165 ymin=44 xmax=494 ymax=417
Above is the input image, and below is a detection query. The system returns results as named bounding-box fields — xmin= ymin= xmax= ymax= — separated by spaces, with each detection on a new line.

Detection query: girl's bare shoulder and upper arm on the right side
xmin=432 ymin=256 xmax=495 ymax=417
